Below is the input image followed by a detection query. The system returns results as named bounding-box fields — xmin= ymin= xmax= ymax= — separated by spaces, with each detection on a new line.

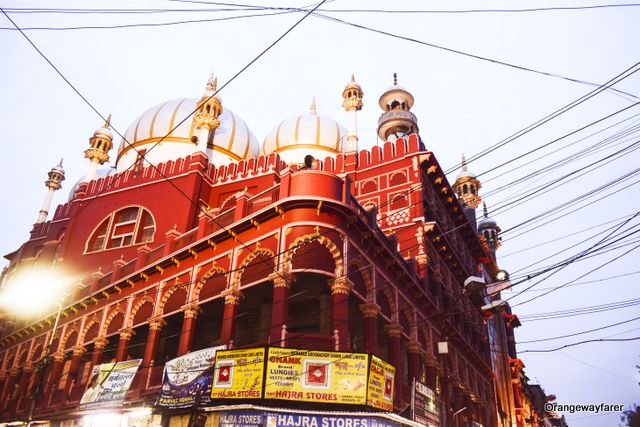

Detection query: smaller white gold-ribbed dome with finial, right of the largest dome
xmin=262 ymin=102 xmax=347 ymax=163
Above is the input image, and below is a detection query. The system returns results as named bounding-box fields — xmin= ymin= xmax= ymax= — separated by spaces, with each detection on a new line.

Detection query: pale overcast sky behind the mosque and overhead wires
xmin=0 ymin=0 xmax=640 ymax=427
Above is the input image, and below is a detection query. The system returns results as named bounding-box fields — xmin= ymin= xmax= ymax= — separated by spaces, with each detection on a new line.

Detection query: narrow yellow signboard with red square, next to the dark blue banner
xmin=211 ymin=348 xmax=265 ymax=399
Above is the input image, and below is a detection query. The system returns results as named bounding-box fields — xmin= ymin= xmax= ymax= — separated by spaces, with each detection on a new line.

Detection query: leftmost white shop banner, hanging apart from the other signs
xmin=78 ymin=359 xmax=142 ymax=410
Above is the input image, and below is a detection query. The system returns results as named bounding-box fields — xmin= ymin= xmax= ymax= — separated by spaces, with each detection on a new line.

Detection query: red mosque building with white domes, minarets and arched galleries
xmin=0 ymin=74 xmax=511 ymax=427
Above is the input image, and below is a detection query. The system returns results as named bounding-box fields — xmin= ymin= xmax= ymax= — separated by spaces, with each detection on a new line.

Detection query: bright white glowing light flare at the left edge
xmin=0 ymin=267 xmax=72 ymax=317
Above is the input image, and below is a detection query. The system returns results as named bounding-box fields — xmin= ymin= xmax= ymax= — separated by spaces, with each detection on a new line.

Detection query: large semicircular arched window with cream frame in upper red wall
xmin=85 ymin=206 xmax=156 ymax=252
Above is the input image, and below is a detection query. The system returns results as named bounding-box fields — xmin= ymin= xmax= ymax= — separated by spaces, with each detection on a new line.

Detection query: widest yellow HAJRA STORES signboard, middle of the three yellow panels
xmin=264 ymin=348 xmax=369 ymax=405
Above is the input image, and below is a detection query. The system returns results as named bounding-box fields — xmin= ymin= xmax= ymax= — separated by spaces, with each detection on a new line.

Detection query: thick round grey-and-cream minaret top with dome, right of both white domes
xmin=378 ymin=73 xmax=418 ymax=141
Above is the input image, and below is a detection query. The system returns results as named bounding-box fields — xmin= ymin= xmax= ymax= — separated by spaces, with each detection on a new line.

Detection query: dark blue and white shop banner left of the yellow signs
xmin=156 ymin=345 xmax=226 ymax=409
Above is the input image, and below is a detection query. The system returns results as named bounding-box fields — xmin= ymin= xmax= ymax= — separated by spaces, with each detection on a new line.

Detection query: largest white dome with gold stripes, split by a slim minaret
xmin=116 ymin=98 xmax=260 ymax=172
